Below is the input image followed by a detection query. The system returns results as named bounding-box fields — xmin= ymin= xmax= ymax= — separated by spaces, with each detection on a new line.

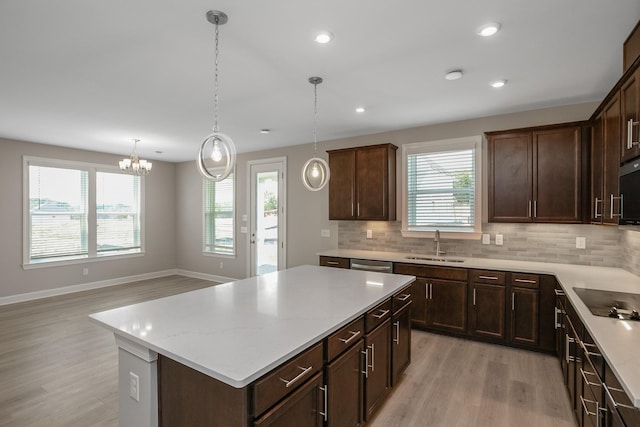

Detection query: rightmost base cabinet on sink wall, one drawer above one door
xmin=509 ymin=273 xmax=540 ymax=347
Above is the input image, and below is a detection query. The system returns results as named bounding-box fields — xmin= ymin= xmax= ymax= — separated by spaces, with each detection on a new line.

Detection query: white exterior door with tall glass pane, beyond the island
xmin=248 ymin=158 xmax=287 ymax=276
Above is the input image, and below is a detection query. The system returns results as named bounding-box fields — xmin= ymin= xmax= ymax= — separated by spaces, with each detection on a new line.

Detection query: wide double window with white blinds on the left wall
xmin=23 ymin=157 xmax=142 ymax=267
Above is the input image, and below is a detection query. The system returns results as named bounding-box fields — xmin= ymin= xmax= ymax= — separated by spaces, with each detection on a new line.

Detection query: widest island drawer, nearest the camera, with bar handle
xmin=253 ymin=343 xmax=322 ymax=416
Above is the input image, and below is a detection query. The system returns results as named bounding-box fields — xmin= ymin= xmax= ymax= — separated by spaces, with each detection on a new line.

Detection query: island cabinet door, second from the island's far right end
xmin=364 ymin=319 xmax=391 ymax=420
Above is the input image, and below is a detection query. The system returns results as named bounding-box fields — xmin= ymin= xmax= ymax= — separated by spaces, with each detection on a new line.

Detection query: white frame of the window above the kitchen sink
xmin=401 ymin=135 xmax=483 ymax=239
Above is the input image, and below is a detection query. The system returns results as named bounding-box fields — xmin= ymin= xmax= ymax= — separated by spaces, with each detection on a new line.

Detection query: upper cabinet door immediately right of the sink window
xmin=488 ymin=132 xmax=533 ymax=222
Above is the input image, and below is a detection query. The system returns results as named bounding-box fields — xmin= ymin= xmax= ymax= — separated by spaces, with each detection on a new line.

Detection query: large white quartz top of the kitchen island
xmin=90 ymin=265 xmax=415 ymax=388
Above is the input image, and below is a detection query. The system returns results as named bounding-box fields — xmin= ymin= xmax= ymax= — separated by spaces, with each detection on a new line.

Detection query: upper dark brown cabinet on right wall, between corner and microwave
xmin=591 ymin=95 xmax=621 ymax=224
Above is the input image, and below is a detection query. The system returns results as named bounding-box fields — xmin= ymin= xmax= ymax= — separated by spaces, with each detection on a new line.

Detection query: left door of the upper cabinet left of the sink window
xmin=329 ymin=150 xmax=356 ymax=219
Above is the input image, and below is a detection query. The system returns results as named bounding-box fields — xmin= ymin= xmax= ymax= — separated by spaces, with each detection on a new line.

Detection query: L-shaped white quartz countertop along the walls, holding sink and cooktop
xmin=318 ymin=249 xmax=640 ymax=408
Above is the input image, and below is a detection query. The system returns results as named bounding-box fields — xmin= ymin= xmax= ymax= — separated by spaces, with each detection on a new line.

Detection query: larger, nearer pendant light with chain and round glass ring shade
xmin=198 ymin=10 xmax=236 ymax=182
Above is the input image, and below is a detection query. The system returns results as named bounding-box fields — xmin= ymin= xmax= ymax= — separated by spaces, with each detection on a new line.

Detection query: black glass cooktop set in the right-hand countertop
xmin=573 ymin=288 xmax=640 ymax=321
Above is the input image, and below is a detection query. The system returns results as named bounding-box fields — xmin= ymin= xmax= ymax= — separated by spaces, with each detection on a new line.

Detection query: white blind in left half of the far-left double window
xmin=29 ymin=165 xmax=89 ymax=262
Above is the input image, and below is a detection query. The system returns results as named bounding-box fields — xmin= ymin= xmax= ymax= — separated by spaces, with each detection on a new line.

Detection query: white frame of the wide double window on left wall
xmin=22 ymin=156 xmax=146 ymax=270
